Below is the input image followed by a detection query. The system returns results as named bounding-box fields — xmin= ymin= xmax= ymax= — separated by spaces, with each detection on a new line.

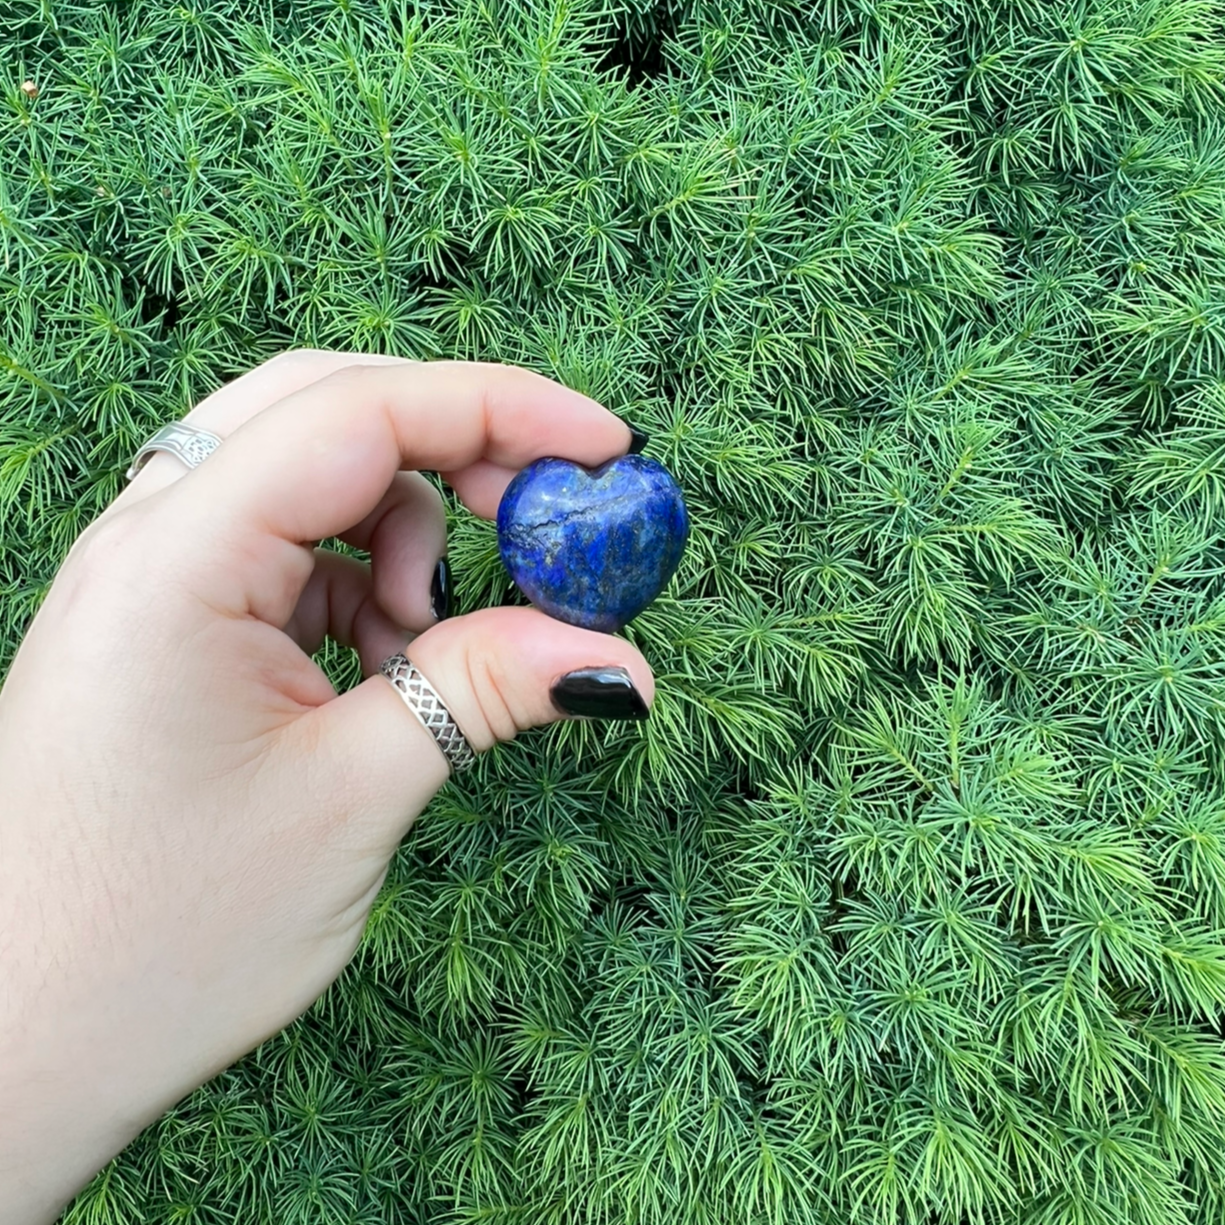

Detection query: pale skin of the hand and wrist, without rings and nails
xmin=0 ymin=350 xmax=654 ymax=1225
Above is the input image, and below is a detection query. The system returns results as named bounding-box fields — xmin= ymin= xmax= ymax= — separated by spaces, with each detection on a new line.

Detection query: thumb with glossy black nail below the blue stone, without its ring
xmin=309 ymin=608 xmax=655 ymax=813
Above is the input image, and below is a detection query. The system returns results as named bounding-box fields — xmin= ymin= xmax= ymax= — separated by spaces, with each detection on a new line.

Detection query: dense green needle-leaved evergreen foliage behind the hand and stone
xmin=0 ymin=0 xmax=1225 ymax=1225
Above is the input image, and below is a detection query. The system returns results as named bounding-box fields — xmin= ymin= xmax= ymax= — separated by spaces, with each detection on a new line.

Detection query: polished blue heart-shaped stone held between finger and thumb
xmin=497 ymin=454 xmax=688 ymax=633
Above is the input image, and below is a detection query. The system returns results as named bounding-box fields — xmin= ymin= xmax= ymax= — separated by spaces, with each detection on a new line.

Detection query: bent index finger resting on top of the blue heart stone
xmin=159 ymin=361 xmax=631 ymax=624
